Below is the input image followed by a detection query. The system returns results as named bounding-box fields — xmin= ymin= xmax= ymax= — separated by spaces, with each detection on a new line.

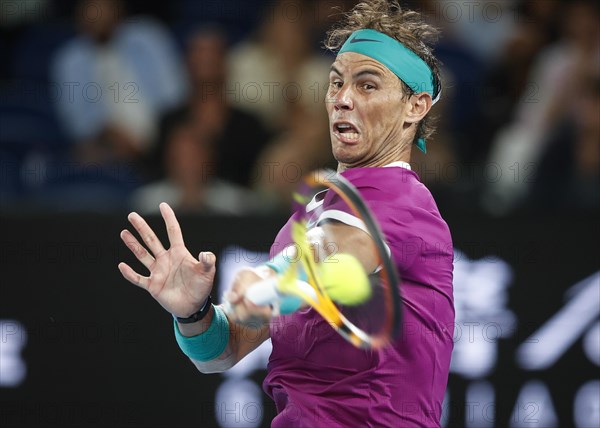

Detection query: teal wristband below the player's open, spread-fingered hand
xmin=173 ymin=306 xmax=229 ymax=362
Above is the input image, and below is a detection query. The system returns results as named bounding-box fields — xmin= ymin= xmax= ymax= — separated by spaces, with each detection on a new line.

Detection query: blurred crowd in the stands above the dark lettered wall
xmin=0 ymin=0 xmax=600 ymax=215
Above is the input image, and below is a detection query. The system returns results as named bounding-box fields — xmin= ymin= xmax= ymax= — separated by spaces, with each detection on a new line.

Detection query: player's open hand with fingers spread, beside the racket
xmin=119 ymin=202 xmax=216 ymax=318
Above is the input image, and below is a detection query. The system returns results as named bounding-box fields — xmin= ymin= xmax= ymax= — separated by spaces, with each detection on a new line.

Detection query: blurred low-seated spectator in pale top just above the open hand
xmin=132 ymin=124 xmax=258 ymax=215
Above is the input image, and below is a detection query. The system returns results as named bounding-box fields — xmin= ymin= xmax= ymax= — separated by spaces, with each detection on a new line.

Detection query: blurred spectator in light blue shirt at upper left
xmin=52 ymin=0 xmax=186 ymax=162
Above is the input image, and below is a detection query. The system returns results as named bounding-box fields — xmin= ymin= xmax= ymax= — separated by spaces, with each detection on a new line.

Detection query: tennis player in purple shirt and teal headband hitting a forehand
xmin=119 ymin=0 xmax=454 ymax=427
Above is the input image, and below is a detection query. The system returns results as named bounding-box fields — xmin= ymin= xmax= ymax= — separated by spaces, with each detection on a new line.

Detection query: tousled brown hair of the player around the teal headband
xmin=324 ymin=0 xmax=442 ymax=145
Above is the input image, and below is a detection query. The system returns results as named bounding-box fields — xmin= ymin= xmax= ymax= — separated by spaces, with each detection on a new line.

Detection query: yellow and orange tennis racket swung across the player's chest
xmin=224 ymin=170 xmax=401 ymax=348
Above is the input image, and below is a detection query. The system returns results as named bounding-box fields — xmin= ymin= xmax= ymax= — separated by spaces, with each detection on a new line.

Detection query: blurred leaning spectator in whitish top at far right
xmin=484 ymin=0 xmax=600 ymax=214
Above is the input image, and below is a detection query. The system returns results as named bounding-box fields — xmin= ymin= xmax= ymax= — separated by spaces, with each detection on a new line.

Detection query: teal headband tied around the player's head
xmin=338 ymin=29 xmax=441 ymax=153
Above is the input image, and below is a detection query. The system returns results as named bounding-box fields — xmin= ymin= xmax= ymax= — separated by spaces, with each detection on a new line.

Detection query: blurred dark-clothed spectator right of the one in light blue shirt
xmin=151 ymin=26 xmax=271 ymax=186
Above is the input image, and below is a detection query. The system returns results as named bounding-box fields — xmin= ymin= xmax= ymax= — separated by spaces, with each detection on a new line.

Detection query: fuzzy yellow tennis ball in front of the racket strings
xmin=321 ymin=254 xmax=371 ymax=306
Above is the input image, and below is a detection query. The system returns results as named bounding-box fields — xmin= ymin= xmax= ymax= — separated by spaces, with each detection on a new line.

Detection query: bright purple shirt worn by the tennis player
xmin=263 ymin=167 xmax=454 ymax=428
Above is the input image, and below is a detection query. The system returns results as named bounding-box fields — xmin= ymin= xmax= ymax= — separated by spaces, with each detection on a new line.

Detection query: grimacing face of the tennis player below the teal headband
xmin=326 ymin=52 xmax=411 ymax=167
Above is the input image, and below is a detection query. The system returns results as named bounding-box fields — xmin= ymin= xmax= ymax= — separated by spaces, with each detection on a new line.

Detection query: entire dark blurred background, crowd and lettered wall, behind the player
xmin=0 ymin=0 xmax=600 ymax=427
